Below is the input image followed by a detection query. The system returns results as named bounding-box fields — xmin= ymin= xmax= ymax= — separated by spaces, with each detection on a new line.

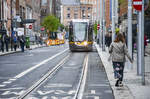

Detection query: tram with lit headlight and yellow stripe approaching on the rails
xmin=69 ymin=19 xmax=93 ymax=51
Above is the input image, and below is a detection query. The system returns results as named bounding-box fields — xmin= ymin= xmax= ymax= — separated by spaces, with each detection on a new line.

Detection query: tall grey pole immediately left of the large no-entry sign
xmin=128 ymin=0 xmax=132 ymax=69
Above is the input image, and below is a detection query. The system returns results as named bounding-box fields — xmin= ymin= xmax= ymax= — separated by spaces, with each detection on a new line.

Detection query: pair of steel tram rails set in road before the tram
xmin=16 ymin=53 xmax=88 ymax=99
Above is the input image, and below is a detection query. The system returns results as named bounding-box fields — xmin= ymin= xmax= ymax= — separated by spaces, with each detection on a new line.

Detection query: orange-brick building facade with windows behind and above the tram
xmin=61 ymin=1 xmax=93 ymax=26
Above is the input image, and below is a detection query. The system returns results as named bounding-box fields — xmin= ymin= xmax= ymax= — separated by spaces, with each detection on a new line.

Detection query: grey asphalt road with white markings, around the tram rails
xmin=0 ymin=45 xmax=114 ymax=99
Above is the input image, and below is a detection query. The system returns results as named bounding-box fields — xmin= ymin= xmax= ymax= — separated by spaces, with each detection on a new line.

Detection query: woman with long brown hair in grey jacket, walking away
xmin=109 ymin=33 xmax=133 ymax=87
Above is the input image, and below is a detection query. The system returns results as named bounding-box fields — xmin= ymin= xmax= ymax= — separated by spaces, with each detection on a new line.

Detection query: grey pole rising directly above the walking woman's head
xmin=112 ymin=0 xmax=115 ymax=42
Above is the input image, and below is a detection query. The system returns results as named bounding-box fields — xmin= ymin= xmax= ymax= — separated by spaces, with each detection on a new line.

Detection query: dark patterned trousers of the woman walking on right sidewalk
xmin=113 ymin=62 xmax=124 ymax=81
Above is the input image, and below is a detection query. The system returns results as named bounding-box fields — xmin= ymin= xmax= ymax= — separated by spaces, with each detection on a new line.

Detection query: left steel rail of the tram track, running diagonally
xmin=16 ymin=54 xmax=70 ymax=99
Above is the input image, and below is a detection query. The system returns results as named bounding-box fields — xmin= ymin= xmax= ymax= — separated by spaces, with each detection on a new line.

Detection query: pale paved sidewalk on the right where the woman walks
xmin=95 ymin=43 xmax=150 ymax=99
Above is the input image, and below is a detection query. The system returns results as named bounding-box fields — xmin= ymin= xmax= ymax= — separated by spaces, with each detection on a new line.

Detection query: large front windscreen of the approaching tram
xmin=73 ymin=22 xmax=87 ymax=41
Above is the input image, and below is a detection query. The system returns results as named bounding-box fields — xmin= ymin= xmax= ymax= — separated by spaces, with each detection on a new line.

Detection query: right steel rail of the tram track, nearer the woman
xmin=73 ymin=54 xmax=88 ymax=99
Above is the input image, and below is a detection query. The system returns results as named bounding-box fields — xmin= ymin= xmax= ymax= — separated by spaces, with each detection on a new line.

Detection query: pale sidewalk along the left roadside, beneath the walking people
xmin=0 ymin=44 xmax=46 ymax=56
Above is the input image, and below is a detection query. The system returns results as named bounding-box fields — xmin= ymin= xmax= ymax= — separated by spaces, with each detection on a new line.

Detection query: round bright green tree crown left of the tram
xmin=42 ymin=15 xmax=62 ymax=33
